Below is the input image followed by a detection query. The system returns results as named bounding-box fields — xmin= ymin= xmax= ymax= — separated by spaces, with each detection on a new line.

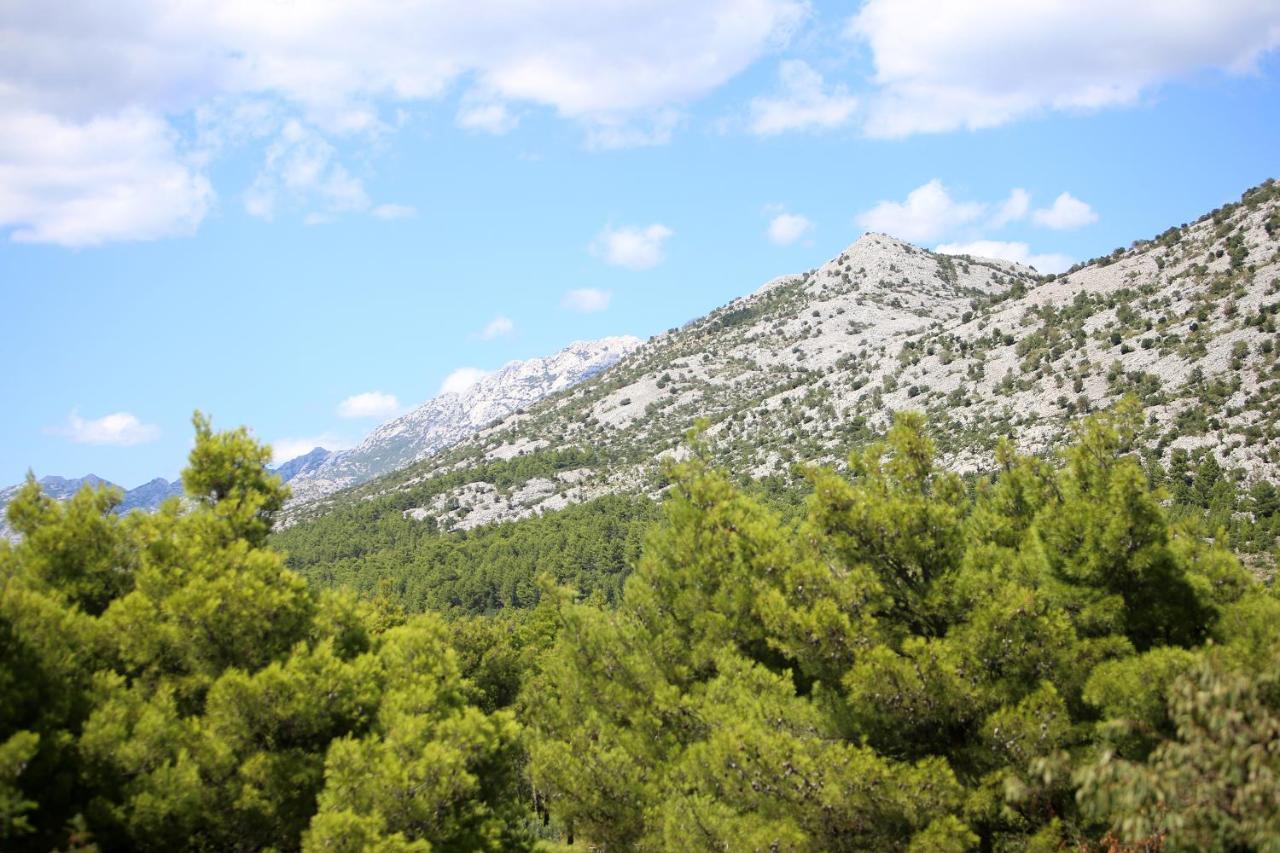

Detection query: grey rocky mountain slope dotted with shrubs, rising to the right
xmin=285 ymin=182 xmax=1280 ymax=528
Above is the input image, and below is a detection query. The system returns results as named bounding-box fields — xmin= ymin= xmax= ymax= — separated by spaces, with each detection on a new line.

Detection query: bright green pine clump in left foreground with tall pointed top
xmin=0 ymin=415 xmax=525 ymax=850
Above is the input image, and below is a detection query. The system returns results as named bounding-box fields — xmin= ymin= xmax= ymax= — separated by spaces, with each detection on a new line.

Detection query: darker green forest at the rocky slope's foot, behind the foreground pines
xmin=270 ymin=432 xmax=1280 ymax=616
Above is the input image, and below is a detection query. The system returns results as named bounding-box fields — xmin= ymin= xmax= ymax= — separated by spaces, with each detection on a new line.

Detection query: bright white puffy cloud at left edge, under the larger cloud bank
xmin=0 ymin=108 xmax=214 ymax=247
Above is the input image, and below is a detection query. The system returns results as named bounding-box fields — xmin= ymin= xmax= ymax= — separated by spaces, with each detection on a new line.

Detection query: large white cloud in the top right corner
xmin=847 ymin=0 xmax=1280 ymax=137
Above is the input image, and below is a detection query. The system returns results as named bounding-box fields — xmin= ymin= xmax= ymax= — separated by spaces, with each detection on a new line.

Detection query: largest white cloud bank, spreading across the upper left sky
xmin=0 ymin=0 xmax=808 ymax=246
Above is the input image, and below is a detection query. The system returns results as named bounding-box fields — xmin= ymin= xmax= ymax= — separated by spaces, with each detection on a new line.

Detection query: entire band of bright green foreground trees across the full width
xmin=0 ymin=406 xmax=1280 ymax=850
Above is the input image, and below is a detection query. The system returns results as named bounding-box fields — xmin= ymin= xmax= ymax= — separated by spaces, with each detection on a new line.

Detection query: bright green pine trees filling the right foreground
xmin=525 ymin=406 xmax=1280 ymax=850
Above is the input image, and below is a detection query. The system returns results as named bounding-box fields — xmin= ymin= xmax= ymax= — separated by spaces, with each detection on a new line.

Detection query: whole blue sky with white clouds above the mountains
xmin=0 ymin=0 xmax=1280 ymax=487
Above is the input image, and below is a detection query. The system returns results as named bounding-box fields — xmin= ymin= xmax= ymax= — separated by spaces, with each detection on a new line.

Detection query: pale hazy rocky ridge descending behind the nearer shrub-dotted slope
xmin=293 ymin=337 xmax=641 ymax=505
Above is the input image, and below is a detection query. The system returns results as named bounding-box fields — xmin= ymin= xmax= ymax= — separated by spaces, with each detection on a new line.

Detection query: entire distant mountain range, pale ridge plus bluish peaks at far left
xmin=0 ymin=337 xmax=641 ymax=538
